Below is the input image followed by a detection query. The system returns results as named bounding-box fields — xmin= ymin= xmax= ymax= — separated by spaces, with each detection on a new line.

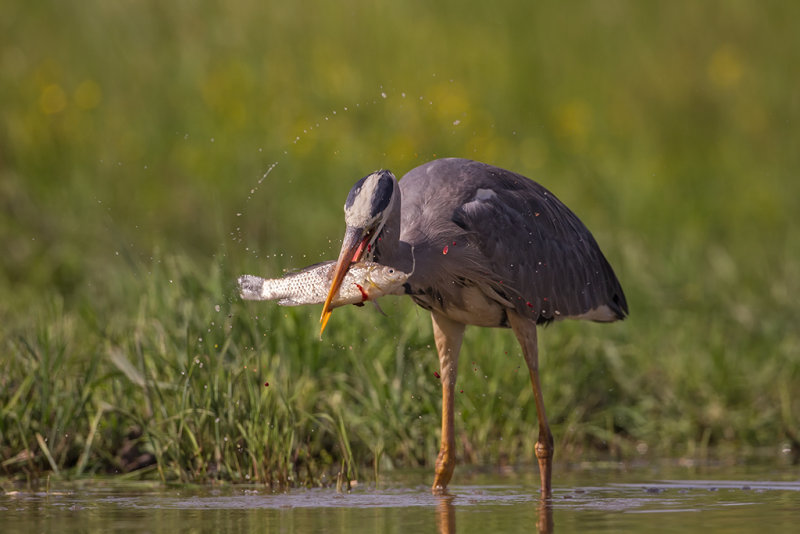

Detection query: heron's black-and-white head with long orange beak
xmin=319 ymin=170 xmax=399 ymax=336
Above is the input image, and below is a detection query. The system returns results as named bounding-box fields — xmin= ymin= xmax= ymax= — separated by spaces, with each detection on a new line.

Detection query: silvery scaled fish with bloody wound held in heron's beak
xmin=238 ymin=261 xmax=410 ymax=308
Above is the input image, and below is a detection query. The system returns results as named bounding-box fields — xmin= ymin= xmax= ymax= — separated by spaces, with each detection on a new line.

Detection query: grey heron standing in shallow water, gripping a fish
xmin=320 ymin=158 xmax=628 ymax=497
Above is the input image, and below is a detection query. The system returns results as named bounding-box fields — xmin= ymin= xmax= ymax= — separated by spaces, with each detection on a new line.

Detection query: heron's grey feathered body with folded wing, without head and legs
xmin=399 ymin=158 xmax=628 ymax=326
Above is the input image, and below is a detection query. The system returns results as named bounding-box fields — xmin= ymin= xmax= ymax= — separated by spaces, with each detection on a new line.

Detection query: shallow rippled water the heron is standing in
xmin=0 ymin=468 xmax=800 ymax=534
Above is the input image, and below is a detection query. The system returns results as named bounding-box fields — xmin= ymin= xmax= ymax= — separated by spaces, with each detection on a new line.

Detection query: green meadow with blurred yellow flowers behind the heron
xmin=0 ymin=0 xmax=800 ymax=479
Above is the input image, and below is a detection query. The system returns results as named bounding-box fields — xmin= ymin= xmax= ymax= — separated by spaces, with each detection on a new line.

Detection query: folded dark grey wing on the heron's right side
xmin=453 ymin=164 xmax=628 ymax=322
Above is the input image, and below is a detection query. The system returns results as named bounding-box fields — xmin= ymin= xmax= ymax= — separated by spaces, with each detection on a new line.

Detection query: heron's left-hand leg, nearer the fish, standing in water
xmin=431 ymin=312 xmax=464 ymax=494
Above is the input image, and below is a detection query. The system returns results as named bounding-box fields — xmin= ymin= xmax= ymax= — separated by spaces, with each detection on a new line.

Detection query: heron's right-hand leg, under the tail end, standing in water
xmin=508 ymin=311 xmax=554 ymax=498
